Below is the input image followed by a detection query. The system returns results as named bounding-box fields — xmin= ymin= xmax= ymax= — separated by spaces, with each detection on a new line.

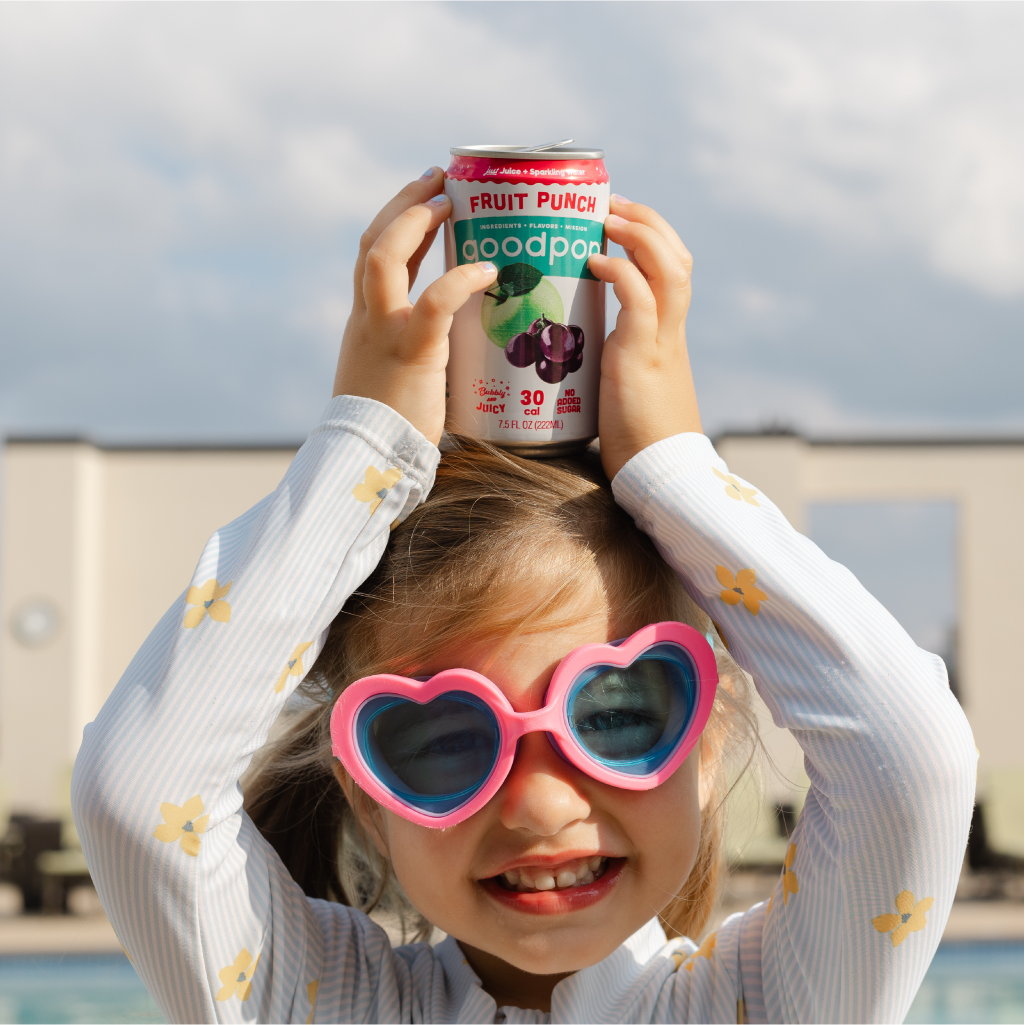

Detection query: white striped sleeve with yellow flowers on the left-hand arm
xmin=73 ymin=397 xmax=439 ymax=1021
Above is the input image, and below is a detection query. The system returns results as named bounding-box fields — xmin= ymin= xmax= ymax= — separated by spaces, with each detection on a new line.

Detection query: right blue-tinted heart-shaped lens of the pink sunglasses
xmin=567 ymin=643 xmax=698 ymax=776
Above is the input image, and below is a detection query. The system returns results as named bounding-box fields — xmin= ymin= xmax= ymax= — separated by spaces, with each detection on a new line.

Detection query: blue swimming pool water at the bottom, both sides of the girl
xmin=0 ymin=943 xmax=1025 ymax=1025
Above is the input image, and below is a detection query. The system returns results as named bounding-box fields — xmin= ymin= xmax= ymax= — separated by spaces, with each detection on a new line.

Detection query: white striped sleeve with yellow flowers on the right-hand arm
xmin=613 ymin=434 xmax=976 ymax=1022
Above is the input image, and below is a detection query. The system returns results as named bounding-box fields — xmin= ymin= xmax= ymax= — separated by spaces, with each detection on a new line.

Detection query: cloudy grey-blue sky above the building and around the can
xmin=0 ymin=2 xmax=1023 ymax=443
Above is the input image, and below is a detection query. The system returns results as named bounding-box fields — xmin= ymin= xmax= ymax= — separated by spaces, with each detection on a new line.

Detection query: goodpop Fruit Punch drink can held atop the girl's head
xmin=445 ymin=146 xmax=609 ymax=456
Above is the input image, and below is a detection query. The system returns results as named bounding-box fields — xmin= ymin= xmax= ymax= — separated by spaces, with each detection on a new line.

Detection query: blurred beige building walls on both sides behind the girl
xmin=0 ymin=435 xmax=1025 ymax=861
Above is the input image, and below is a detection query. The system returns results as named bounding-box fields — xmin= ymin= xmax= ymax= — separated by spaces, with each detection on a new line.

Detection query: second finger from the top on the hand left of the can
xmin=362 ymin=196 xmax=452 ymax=317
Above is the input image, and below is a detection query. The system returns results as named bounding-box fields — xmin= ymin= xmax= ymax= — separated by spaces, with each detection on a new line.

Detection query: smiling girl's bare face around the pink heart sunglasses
xmin=336 ymin=600 xmax=701 ymax=1006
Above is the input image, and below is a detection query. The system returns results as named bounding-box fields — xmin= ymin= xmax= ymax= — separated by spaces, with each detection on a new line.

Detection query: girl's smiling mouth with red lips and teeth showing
xmin=481 ymin=856 xmax=626 ymax=914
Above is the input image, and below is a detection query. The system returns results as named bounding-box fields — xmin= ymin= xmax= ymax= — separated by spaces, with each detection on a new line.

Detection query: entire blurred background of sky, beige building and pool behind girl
xmin=0 ymin=2 xmax=1023 ymax=1021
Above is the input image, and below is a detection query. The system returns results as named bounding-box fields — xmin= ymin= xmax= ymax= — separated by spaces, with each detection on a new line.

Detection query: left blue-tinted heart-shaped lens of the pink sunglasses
xmin=356 ymin=691 xmax=499 ymax=815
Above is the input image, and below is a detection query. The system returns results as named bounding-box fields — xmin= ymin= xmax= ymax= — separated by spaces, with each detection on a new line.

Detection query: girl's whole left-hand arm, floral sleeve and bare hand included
xmin=73 ymin=168 xmax=495 ymax=1021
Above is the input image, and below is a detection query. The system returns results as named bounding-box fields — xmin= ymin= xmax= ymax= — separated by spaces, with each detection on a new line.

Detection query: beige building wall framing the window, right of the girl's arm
xmin=716 ymin=436 xmax=1025 ymax=854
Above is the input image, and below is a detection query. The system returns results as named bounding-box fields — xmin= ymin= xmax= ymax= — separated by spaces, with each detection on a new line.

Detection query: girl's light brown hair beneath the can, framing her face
xmin=243 ymin=439 xmax=755 ymax=939
